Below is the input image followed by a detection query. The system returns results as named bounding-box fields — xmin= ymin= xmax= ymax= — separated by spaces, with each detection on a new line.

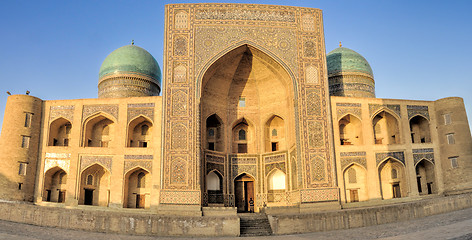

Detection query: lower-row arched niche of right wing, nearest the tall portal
xmin=343 ymin=164 xmax=369 ymax=202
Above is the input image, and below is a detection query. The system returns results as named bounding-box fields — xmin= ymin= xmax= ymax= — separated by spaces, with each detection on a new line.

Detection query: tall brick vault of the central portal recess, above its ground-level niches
xmin=199 ymin=44 xmax=295 ymax=153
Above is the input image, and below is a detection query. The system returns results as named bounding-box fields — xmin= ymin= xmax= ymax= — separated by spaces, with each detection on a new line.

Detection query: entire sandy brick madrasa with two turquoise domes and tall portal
xmin=0 ymin=4 xmax=472 ymax=216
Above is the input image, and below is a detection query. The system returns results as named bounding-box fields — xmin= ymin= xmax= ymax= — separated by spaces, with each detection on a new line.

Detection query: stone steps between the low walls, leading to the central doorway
xmin=238 ymin=213 xmax=272 ymax=237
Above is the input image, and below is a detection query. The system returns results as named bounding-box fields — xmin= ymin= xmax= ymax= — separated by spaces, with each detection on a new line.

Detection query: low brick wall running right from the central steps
xmin=269 ymin=193 xmax=472 ymax=234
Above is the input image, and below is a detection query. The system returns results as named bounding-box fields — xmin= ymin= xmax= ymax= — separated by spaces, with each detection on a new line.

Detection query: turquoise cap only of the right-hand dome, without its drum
xmin=326 ymin=47 xmax=374 ymax=77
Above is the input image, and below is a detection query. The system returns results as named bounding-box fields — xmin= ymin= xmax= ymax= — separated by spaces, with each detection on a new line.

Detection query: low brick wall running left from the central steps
xmin=0 ymin=202 xmax=239 ymax=237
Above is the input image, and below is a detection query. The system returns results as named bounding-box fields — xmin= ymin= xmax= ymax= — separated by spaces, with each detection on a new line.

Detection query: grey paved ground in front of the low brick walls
xmin=0 ymin=208 xmax=472 ymax=240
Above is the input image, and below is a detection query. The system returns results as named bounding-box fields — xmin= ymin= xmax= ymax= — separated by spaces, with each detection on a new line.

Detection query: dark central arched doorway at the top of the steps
xmin=234 ymin=173 xmax=256 ymax=212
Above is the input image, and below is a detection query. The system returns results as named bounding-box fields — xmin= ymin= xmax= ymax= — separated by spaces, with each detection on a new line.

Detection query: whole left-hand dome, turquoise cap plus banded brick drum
xmin=98 ymin=44 xmax=161 ymax=98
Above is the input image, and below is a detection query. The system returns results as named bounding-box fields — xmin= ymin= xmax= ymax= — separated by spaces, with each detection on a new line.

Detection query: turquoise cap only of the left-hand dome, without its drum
xmin=98 ymin=45 xmax=161 ymax=83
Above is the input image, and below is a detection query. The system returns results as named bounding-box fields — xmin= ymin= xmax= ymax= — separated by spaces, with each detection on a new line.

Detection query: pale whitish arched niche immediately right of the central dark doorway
xmin=267 ymin=169 xmax=287 ymax=203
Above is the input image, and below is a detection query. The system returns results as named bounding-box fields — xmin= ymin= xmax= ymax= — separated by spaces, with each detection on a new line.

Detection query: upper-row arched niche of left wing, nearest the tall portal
xmin=127 ymin=116 xmax=153 ymax=148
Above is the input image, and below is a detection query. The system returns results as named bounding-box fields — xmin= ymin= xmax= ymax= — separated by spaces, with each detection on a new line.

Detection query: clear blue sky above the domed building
xmin=0 ymin=0 xmax=472 ymax=132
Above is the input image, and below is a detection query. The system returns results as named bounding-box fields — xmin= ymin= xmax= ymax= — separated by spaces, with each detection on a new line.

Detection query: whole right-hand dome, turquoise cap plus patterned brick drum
xmin=326 ymin=44 xmax=375 ymax=98
